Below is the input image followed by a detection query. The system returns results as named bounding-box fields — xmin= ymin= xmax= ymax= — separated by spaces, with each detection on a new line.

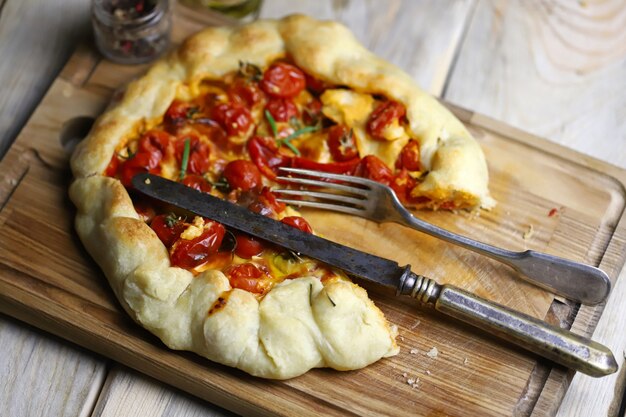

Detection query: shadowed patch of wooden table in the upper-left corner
xmin=0 ymin=0 xmax=90 ymax=158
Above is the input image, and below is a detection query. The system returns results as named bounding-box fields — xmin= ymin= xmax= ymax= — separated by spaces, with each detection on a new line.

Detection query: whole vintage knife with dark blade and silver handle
xmin=132 ymin=173 xmax=617 ymax=377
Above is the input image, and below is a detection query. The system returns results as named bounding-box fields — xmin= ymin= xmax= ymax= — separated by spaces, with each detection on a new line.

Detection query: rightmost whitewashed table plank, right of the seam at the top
xmin=444 ymin=0 xmax=626 ymax=416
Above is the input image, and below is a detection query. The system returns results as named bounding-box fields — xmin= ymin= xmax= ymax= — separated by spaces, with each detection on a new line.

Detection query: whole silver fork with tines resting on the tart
xmin=272 ymin=168 xmax=611 ymax=305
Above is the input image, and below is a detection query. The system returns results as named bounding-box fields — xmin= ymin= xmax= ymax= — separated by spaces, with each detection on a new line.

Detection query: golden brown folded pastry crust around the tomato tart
xmin=70 ymin=16 xmax=489 ymax=378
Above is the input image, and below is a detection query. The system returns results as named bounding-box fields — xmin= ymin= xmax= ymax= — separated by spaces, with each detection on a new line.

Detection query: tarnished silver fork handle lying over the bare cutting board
xmin=401 ymin=213 xmax=611 ymax=305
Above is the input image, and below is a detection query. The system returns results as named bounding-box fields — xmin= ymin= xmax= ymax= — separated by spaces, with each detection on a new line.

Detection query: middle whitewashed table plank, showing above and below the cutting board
xmin=89 ymin=0 xmax=473 ymax=417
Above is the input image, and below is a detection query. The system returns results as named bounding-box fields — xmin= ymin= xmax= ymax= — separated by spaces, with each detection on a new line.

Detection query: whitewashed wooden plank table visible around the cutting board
xmin=0 ymin=0 xmax=626 ymax=417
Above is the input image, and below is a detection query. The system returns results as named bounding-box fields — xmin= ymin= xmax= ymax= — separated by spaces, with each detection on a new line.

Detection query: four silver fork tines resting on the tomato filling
xmin=272 ymin=168 xmax=369 ymax=214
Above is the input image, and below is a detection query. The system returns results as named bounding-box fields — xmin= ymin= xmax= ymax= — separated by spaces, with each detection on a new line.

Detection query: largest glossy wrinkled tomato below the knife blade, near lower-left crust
xmin=170 ymin=221 xmax=226 ymax=269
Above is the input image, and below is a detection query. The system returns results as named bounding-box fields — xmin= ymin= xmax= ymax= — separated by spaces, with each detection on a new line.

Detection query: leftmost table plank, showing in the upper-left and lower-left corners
xmin=0 ymin=0 xmax=106 ymax=416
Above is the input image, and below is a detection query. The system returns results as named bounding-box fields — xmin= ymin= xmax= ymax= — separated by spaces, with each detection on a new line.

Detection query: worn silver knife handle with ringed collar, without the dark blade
xmin=398 ymin=271 xmax=618 ymax=377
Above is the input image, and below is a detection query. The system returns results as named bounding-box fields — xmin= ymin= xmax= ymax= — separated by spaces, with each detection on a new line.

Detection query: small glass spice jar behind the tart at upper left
xmin=91 ymin=0 xmax=172 ymax=64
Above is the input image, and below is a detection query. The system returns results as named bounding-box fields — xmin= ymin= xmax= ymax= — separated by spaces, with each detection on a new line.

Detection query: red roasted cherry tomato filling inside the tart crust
xmin=104 ymin=59 xmax=434 ymax=295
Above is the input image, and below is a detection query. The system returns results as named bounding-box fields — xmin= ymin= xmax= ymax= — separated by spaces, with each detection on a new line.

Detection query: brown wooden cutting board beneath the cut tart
xmin=0 ymin=11 xmax=626 ymax=416
